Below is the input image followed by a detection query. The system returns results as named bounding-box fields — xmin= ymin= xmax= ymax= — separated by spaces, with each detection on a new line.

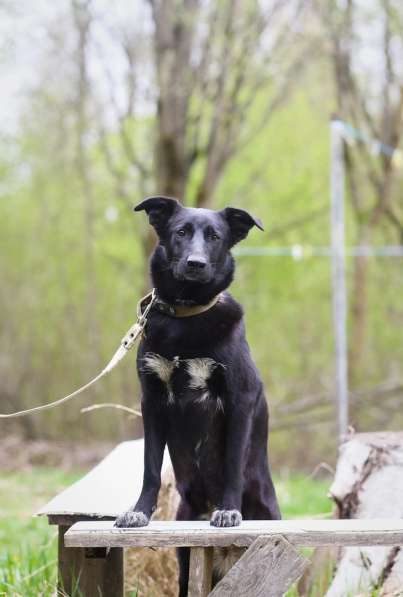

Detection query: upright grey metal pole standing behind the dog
xmin=330 ymin=119 xmax=348 ymax=443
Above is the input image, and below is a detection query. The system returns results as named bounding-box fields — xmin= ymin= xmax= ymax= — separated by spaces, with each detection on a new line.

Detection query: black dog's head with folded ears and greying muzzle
xmin=134 ymin=197 xmax=263 ymax=283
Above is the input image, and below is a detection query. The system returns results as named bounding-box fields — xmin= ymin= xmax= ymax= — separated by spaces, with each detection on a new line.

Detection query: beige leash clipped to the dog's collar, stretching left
xmin=0 ymin=288 xmax=157 ymax=419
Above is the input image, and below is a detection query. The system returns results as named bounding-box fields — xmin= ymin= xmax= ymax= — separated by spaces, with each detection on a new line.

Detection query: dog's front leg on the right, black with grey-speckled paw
xmin=210 ymin=407 xmax=250 ymax=527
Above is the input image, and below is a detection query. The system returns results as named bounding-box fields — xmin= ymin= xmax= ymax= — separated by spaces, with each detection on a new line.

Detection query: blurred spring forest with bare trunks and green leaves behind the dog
xmin=0 ymin=0 xmax=403 ymax=467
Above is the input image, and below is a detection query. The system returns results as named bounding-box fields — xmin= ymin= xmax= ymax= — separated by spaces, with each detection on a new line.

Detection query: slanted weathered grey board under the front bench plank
xmin=210 ymin=535 xmax=309 ymax=597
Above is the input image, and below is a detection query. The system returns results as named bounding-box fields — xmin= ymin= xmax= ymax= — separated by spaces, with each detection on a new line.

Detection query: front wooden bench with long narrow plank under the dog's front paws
xmin=64 ymin=519 xmax=403 ymax=597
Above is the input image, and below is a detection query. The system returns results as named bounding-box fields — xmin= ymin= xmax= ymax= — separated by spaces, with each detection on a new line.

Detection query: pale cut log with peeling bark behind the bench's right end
xmin=326 ymin=432 xmax=403 ymax=597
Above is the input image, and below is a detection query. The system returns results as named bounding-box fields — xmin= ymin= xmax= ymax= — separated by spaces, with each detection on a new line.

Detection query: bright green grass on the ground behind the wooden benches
xmin=0 ymin=467 xmax=331 ymax=597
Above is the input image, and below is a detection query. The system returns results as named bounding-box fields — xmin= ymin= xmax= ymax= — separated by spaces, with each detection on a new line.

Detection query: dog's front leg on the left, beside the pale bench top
xmin=115 ymin=400 xmax=166 ymax=527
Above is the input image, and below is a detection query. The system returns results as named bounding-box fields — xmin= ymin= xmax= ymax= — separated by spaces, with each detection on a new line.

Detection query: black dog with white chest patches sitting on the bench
xmin=116 ymin=197 xmax=280 ymax=597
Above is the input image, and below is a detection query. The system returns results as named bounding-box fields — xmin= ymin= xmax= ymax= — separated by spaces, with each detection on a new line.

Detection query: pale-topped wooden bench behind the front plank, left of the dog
xmin=36 ymin=439 xmax=171 ymax=597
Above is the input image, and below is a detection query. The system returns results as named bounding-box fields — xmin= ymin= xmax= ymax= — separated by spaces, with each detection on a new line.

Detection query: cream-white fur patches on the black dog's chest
xmin=143 ymin=352 xmax=223 ymax=410
